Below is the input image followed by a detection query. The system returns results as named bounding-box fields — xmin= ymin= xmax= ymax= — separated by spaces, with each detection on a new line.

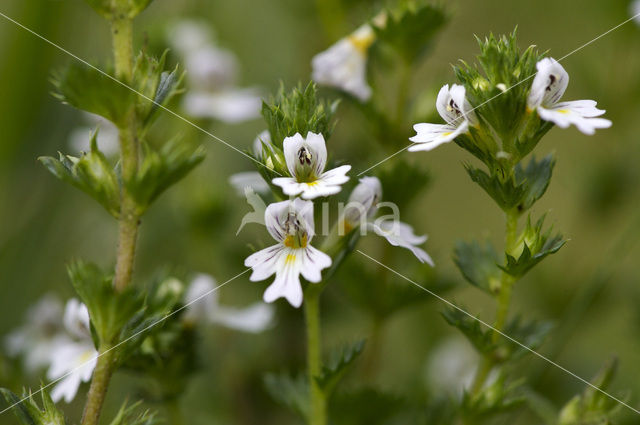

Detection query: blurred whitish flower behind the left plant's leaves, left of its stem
xmin=69 ymin=112 xmax=120 ymax=157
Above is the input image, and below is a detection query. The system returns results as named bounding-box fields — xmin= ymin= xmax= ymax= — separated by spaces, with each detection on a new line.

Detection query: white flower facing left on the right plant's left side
xmin=409 ymin=84 xmax=477 ymax=152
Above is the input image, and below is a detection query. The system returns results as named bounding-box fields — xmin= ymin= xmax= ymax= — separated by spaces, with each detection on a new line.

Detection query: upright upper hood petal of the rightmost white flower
xmin=527 ymin=58 xmax=569 ymax=109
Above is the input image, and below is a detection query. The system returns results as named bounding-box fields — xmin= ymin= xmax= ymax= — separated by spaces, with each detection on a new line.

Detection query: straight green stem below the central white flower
xmin=304 ymin=290 xmax=327 ymax=425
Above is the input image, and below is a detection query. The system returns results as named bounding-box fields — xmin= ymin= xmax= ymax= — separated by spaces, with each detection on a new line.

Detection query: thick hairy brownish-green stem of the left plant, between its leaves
xmin=81 ymin=14 xmax=139 ymax=425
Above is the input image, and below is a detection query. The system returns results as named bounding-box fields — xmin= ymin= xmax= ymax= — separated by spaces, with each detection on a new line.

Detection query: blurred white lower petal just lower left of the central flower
xmin=212 ymin=302 xmax=275 ymax=333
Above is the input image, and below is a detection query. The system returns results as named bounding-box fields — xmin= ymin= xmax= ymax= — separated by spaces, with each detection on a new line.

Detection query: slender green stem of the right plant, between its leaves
xmin=471 ymin=211 xmax=518 ymax=394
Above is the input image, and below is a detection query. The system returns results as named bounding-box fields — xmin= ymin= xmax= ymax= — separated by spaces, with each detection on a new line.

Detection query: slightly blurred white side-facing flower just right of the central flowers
xmin=343 ymin=177 xmax=434 ymax=266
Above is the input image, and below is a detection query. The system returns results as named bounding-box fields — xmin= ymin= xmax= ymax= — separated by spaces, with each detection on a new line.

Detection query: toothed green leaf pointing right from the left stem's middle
xmin=124 ymin=139 xmax=205 ymax=214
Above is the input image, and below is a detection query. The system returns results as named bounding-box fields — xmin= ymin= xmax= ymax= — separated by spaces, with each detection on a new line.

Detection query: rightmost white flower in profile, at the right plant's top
xmin=527 ymin=58 xmax=611 ymax=135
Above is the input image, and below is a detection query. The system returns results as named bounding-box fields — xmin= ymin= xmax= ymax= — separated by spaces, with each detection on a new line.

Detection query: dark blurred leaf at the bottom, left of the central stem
xmin=264 ymin=373 xmax=311 ymax=420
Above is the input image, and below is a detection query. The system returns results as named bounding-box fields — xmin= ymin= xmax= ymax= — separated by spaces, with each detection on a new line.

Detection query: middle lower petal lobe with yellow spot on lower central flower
xmin=264 ymin=248 xmax=304 ymax=307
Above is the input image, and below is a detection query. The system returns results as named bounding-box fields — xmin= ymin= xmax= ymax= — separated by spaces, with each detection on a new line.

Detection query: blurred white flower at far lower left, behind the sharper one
xmin=4 ymin=295 xmax=62 ymax=373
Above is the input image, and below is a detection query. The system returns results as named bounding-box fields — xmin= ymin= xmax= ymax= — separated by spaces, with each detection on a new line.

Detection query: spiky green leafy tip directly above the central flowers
xmin=262 ymin=82 xmax=338 ymax=147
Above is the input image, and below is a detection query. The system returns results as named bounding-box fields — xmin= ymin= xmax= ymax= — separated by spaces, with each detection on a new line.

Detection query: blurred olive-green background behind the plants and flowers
xmin=0 ymin=0 xmax=640 ymax=424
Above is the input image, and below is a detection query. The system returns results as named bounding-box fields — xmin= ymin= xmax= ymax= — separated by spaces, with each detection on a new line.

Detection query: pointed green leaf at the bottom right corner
xmin=558 ymin=358 xmax=627 ymax=425
